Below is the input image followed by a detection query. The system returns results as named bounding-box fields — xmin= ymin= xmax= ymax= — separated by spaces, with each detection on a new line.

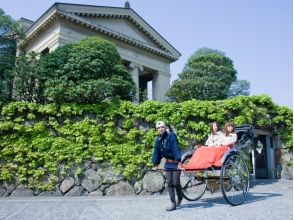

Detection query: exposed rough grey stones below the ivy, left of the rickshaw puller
xmin=0 ymin=161 xmax=166 ymax=197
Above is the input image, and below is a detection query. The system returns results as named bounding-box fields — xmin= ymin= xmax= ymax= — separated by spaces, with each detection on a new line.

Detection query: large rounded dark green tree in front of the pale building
xmin=40 ymin=37 xmax=136 ymax=103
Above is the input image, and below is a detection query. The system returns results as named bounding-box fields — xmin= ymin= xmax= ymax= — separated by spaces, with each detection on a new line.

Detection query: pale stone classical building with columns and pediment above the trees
xmin=18 ymin=2 xmax=181 ymax=101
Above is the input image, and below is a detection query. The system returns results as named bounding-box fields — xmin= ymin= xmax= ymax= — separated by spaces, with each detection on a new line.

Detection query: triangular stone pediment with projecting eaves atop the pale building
xmin=18 ymin=3 xmax=181 ymax=62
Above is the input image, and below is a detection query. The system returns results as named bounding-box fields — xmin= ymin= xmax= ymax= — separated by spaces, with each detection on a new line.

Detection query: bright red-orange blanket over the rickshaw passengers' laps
xmin=183 ymin=146 xmax=230 ymax=170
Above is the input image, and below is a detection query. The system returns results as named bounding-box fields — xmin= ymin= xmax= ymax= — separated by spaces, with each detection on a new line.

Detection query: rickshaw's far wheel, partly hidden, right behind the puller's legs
xmin=180 ymin=156 xmax=206 ymax=201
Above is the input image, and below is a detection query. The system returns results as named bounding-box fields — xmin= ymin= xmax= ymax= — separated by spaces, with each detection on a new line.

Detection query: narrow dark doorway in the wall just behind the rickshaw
xmin=254 ymin=135 xmax=268 ymax=178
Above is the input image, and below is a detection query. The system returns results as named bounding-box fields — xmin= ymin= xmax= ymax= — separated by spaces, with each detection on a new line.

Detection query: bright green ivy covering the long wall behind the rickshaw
xmin=0 ymin=96 xmax=293 ymax=190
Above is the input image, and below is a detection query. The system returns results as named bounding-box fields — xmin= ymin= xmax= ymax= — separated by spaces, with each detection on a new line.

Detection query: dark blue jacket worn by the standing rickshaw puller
xmin=152 ymin=132 xmax=181 ymax=165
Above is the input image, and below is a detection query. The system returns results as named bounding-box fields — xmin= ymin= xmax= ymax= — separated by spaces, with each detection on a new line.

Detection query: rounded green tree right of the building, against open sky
xmin=167 ymin=48 xmax=237 ymax=102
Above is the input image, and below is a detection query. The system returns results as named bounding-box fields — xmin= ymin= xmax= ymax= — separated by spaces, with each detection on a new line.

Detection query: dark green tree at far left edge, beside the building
xmin=0 ymin=8 xmax=24 ymax=102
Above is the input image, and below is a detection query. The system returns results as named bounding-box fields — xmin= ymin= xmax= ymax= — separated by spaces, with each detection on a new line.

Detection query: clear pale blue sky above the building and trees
xmin=0 ymin=0 xmax=293 ymax=109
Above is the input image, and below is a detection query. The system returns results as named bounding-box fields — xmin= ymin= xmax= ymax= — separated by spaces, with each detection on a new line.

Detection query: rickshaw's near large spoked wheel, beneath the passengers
xmin=220 ymin=154 xmax=249 ymax=206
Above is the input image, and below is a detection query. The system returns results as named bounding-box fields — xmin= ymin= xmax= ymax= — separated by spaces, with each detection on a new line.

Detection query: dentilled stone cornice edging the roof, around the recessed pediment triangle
xmin=18 ymin=3 xmax=180 ymax=62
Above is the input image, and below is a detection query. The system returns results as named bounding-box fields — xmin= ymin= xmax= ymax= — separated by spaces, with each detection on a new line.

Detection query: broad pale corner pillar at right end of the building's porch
xmin=152 ymin=71 xmax=171 ymax=102
